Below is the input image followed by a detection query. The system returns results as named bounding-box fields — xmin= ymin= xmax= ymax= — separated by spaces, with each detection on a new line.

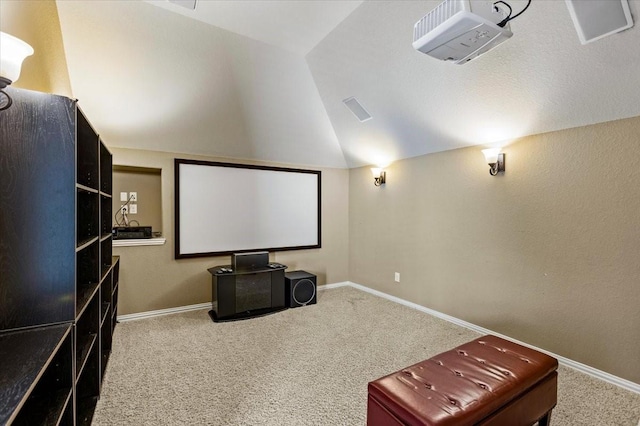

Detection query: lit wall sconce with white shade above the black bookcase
xmin=0 ymin=32 xmax=33 ymax=111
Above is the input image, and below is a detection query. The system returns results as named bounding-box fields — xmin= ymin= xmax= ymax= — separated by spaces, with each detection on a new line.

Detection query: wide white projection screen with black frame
xmin=174 ymin=159 xmax=321 ymax=259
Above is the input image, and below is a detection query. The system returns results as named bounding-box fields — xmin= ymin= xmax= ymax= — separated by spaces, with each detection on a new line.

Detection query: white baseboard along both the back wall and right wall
xmin=117 ymin=281 xmax=640 ymax=396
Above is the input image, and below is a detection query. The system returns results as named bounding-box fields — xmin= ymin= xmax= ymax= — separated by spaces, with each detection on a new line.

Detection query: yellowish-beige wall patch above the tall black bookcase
xmin=0 ymin=0 xmax=72 ymax=97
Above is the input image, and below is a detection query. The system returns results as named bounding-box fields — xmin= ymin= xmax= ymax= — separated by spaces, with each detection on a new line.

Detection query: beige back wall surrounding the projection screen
xmin=109 ymin=147 xmax=349 ymax=315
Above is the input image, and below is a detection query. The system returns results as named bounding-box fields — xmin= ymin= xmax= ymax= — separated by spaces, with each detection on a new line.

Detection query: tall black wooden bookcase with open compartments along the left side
xmin=0 ymin=87 xmax=120 ymax=425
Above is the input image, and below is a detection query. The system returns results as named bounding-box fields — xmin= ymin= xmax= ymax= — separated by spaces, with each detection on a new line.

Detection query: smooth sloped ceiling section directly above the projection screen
xmin=57 ymin=1 xmax=346 ymax=168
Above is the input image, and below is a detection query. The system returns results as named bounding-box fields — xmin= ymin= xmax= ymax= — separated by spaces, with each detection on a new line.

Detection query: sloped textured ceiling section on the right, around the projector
xmin=307 ymin=0 xmax=640 ymax=166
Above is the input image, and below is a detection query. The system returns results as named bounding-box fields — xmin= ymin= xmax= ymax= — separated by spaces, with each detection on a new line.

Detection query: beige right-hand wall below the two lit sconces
xmin=349 ymin=117 xmax=640 ymax=383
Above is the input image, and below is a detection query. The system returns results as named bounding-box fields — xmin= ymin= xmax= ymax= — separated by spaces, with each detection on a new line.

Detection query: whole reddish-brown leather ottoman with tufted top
xmin=367 ymin=336 xmax=558 ymax=426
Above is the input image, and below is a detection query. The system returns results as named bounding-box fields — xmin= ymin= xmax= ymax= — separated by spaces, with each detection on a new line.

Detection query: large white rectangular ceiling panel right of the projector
xmin=565 ymin=0 xmax=633 ymax=44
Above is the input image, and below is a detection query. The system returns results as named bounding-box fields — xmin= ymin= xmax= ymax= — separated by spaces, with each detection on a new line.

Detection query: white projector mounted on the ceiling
xmin=413 ymin=0 xmax=513 ymax=64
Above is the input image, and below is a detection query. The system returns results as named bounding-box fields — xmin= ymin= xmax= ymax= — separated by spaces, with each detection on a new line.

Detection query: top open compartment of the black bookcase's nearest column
xmin=76 ymin=108 xmax=99 ymax=189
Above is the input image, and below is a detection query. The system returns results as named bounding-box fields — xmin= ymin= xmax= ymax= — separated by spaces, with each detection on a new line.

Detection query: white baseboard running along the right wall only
xmin=344 ymin=281 xmax=640 ymax=394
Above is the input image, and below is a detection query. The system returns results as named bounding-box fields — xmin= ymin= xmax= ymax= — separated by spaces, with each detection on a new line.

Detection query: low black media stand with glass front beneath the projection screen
xmin=208 ymin=265 xmax=287 ymax=322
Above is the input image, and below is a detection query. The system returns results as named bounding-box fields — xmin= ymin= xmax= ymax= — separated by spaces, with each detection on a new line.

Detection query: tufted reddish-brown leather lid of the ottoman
xmin=369 ymin=335 xmax=558 ymax=426
